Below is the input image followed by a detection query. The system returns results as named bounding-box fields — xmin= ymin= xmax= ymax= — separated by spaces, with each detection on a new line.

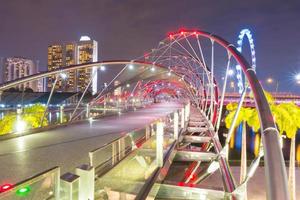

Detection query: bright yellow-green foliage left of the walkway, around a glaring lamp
xmin=0 ymin=104 xmax=48 ymax=135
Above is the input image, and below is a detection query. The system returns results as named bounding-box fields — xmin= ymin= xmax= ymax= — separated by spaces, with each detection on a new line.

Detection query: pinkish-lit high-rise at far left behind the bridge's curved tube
xmin=2 ymin=57 xmax=38 ymax=91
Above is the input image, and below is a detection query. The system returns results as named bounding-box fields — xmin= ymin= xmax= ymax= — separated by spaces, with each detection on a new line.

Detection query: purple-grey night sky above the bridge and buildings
xmin=0 ymin=0 xmax=300 ymax=94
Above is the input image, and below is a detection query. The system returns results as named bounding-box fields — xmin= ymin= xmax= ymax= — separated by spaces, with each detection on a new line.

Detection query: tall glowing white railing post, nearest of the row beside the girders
xmin=156 ymin=122 xmax=164 ymax=167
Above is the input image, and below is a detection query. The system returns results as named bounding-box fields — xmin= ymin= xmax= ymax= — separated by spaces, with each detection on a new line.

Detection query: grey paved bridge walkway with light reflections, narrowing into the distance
xmin=0 ymin=103 xmax=181 ymax=185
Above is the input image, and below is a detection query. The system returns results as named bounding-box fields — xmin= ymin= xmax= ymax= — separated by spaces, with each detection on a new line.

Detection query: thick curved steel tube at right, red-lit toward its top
xmin=190 ymin=31 xmax=289 ymax=200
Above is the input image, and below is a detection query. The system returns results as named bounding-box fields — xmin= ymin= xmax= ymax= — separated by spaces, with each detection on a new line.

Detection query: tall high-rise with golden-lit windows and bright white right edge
xmin=48 ymin=36 xmax=98 ymax=94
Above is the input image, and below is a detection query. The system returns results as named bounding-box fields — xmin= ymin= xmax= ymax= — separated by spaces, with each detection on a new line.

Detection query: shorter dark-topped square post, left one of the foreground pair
xmin=60 ymin=172 xmax=79 ymax=200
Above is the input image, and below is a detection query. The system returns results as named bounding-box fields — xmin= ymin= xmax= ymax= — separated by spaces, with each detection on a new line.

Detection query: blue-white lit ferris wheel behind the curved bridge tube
xmin=236 ymin=29 xmax=256 ymax=94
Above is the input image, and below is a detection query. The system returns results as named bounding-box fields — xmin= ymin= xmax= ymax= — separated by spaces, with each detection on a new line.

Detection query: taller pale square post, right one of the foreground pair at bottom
xmin=75 ymin=164 xmax=95 ymax=200
